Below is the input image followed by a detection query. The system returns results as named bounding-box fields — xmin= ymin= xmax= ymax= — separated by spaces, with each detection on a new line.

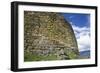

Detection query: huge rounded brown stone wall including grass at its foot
xmin=24 ymin=11 xmax=79 ymax=61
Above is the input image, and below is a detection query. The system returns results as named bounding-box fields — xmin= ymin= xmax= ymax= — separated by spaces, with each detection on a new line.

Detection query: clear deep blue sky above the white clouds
xmin=62 ymin=13 xmax=90 ymax=27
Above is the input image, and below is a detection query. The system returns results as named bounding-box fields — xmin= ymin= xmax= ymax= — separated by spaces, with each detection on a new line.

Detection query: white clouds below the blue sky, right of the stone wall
xmin=72 ymin=25 xmax=90 ymax=51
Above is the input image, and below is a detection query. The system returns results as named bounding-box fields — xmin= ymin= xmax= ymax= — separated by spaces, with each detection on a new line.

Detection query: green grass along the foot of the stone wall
xmin=24 ymin=49 xmax=77 ymax=62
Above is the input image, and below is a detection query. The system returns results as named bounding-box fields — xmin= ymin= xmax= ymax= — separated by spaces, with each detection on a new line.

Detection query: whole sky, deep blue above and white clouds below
xmin=62 ymin=13 xmax=90 ymax=51
